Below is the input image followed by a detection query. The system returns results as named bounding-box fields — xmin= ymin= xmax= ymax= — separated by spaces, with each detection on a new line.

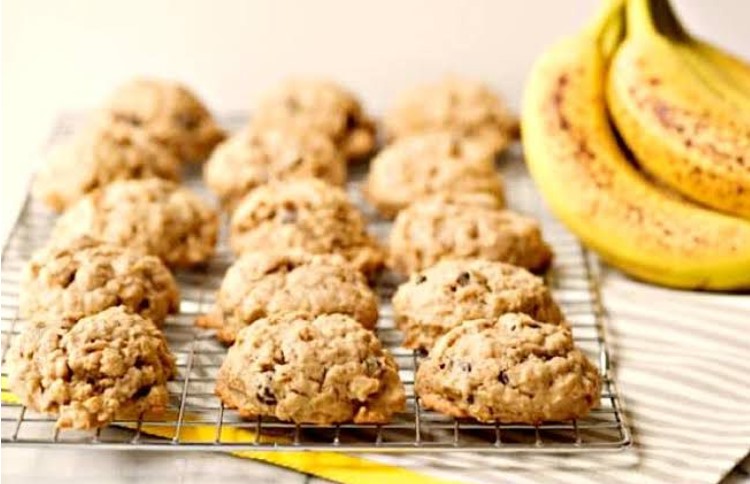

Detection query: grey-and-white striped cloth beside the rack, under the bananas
xmin=356 ymin=269 xmax=750 ymax=484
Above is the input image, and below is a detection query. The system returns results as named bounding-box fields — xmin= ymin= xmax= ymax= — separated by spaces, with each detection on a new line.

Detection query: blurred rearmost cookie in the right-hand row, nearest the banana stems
xmin=384 ymin=77 xmax=518 ymax=155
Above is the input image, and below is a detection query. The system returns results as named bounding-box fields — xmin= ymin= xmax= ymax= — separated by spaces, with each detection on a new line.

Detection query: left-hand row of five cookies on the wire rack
xmin=6 ymin=81 xmax=229 ymax=429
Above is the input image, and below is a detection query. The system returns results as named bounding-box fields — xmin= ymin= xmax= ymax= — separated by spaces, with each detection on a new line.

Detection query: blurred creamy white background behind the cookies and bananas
xmin=2 ymin=0 xmax=750 ymax=235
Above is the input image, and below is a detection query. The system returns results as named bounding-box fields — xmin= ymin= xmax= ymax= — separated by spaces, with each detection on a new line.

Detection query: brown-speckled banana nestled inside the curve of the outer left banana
xmin=607 ymin=0 xmax=750 ymax=218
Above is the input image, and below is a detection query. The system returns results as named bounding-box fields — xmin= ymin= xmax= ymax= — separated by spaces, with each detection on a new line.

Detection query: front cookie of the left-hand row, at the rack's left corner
xmin=6 ymin=307 xmax=176 ymax=429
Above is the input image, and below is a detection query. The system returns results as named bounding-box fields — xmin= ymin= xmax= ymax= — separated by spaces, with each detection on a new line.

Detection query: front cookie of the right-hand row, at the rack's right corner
xmin=415 ymin=313 xmax=601 ymax=425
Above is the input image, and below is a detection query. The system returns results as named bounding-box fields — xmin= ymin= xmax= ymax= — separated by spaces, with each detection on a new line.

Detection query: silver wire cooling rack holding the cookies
xmin=1 ymin=115 xmax=631 ymax=452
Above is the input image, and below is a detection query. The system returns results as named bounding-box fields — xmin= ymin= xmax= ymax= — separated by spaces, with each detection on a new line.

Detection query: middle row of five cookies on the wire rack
xmin=197 ymin=80 xmax=406 ymax=424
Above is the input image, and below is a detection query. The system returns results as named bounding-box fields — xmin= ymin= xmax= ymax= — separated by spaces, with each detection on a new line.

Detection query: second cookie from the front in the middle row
xmin=198 ymin=252 xmax=378 ymax=343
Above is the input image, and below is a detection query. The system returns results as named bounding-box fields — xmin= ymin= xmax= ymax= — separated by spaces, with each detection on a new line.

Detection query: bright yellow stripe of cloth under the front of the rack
xmin=2 ymin=377 xmax=462 ymax=484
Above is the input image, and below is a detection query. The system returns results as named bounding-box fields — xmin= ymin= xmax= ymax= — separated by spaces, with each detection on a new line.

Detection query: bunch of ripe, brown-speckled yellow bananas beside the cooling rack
xmin=522 ymin=0 xmax=750 ymax=290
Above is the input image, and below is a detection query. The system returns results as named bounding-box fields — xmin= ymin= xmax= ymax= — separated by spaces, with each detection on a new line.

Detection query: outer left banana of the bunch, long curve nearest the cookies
xmin=522 ymin=0 xmax=750 ymax=290
